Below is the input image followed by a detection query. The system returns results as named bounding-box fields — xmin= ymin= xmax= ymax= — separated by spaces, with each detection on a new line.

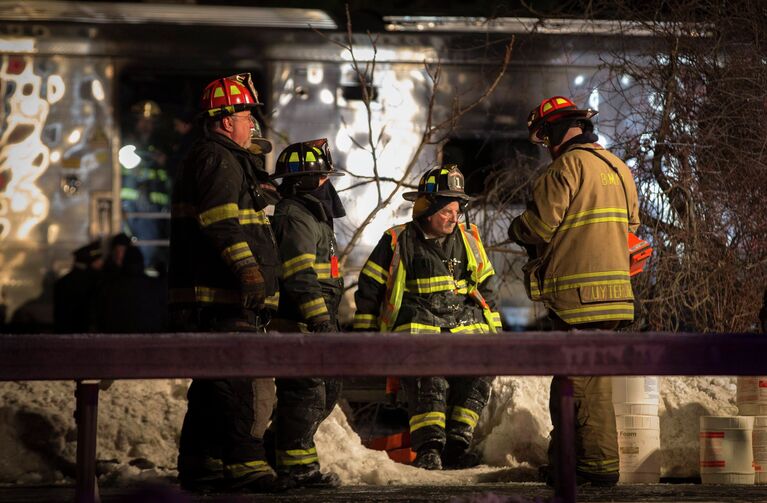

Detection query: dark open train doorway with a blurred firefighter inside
xmin=117 ymin=67 xmax=266 ymax=274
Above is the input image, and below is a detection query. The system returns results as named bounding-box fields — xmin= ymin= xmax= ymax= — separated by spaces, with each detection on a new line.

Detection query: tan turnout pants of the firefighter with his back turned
xmin=548 ymin=319 xmax=618 ymax=482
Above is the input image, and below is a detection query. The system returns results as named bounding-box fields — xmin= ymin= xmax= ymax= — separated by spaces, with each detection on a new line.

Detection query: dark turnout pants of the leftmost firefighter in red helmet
xmin=178 ymin=310 xmax=275 ymax=480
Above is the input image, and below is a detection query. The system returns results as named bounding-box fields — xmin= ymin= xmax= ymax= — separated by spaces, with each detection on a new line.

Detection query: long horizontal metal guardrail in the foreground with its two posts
xmin=0 ymin=331 xmax=767 ymax=503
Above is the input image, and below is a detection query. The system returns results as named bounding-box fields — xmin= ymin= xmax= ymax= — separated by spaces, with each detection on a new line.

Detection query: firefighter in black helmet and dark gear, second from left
xmin=272 ymin=138 xmax=346 ymax=487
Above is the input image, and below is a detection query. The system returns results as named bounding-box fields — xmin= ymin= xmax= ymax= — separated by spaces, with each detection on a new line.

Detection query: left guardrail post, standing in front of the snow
xmin=75 ymin=381 xmax=101 ymax=503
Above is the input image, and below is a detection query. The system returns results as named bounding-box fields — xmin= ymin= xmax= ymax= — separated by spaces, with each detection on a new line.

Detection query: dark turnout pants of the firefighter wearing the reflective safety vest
xmin=401 ymin=377 xmax=492 ymax=451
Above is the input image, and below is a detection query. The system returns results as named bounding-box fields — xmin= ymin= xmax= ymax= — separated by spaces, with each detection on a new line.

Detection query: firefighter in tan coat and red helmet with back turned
xmin=509 ymin=96 xmax=639 ymax=485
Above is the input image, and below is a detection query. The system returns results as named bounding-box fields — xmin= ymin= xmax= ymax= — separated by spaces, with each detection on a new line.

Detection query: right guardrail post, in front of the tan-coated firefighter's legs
xmin=554 ymin=377 xmax=576 ymax=503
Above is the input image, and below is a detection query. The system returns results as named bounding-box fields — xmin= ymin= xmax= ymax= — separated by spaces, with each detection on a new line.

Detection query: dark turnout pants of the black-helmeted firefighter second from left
xmin=275 ymin=378 xmax=341 ymax=472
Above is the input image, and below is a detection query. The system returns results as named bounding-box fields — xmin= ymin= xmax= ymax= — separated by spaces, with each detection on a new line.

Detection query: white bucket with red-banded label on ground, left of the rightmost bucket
xmin=700 ymin=416 xmax=755 ymax=484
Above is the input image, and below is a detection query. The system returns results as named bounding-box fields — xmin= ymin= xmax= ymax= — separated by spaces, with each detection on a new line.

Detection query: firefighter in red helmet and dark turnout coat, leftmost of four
xmin=169 ymin=74 xmax=280 ymax=492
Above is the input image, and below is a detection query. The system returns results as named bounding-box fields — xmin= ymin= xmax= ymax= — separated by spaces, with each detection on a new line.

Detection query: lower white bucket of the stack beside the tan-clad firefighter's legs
xmin=615 ymin=416 xmax=660 ymax=484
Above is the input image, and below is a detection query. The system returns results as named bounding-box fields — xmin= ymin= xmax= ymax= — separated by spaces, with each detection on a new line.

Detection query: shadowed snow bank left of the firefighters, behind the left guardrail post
xmin=0 ymin=379 xmax=189 ymax=483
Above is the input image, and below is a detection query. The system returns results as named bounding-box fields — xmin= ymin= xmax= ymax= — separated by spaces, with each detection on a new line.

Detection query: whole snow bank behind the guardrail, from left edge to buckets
xmin=0 ymin=377 xmax=737 ymax=485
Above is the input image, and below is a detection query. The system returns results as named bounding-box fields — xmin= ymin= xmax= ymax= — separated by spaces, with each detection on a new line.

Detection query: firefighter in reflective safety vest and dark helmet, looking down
xmin=354 ymin=165 xmax=501 ymax=470
